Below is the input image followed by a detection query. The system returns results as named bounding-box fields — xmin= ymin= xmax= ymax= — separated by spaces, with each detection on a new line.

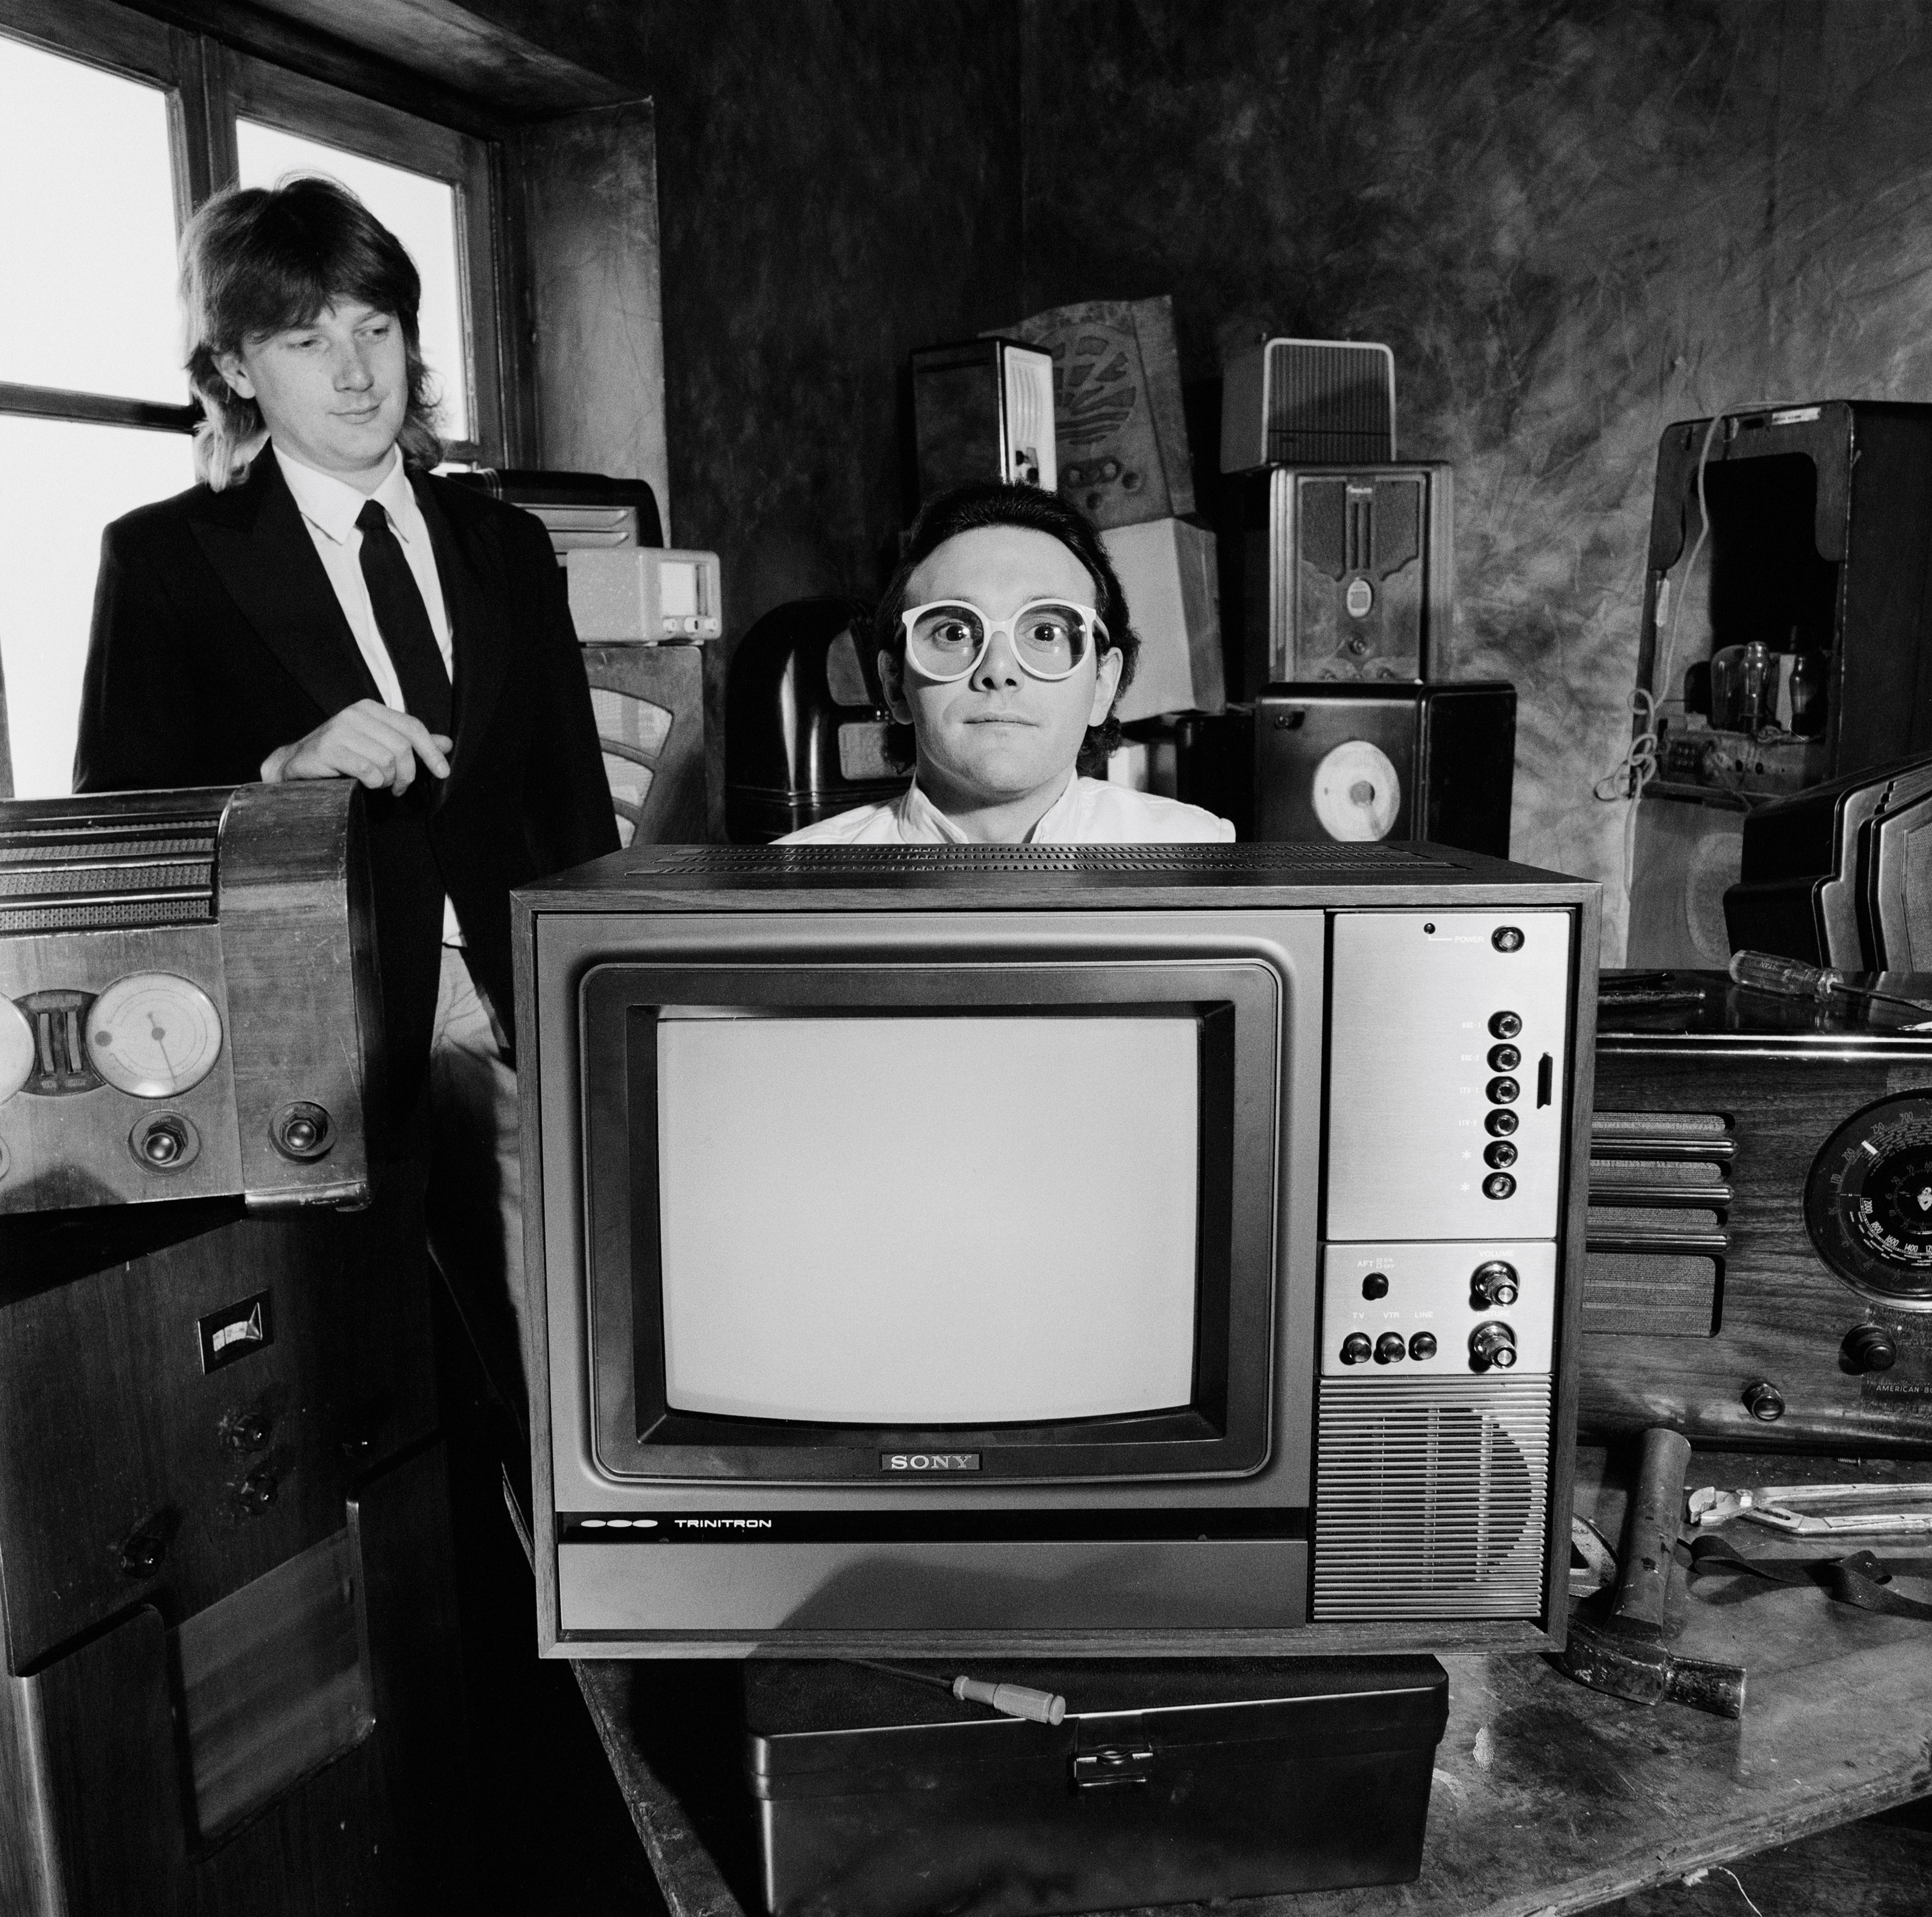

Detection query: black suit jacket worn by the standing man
xmin=73 ymin=454 xmax=618 ymax=1111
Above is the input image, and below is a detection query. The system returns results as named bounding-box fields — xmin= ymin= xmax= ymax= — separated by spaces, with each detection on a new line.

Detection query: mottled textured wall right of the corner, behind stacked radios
xmin=1020 ymin=0 xmax=1932 ymax=957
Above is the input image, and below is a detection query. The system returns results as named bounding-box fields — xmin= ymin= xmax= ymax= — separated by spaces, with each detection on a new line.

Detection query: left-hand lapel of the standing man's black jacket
xmin=193 ymin=448 xmax=381 ymax=717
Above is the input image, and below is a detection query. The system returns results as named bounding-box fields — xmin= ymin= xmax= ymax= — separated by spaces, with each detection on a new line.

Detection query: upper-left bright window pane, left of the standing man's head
xmin=0 ymin=37 xmax=187 ymax=406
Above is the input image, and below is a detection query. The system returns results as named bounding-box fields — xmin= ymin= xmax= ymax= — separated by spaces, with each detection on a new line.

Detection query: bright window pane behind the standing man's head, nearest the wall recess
xmin=236 ymin=120 xmax=469 ymax=439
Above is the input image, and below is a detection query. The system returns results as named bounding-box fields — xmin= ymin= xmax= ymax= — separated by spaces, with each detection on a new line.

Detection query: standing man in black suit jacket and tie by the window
xmin=73 ymin=178 xmax=618 ymax=1397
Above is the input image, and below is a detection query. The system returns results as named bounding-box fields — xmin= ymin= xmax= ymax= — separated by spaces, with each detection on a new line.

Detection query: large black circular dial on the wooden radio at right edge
xmin=1804 ymin=1092 xmax=1932 ymax=1310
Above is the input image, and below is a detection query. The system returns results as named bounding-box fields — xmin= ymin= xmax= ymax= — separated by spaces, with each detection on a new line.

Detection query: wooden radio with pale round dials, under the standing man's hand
xmin=0 ymin=779 xmax=379 ymax=1214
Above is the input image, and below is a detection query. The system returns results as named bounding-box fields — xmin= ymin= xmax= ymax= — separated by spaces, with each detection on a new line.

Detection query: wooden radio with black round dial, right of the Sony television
xmin=1580 ymin=972 xmax=1932 ymax=1455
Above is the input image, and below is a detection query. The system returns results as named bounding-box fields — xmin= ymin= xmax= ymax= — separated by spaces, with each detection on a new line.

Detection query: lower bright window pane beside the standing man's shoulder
xmin=0 ymin=414 xmax=195 ymax=798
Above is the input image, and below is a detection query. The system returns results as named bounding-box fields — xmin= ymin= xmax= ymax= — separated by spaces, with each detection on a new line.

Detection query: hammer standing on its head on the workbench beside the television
xmin=1563 ymin=1424 xmax=1745 ymax=1718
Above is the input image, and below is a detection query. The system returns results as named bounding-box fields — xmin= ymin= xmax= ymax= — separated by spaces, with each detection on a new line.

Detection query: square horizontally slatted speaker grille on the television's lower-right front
xmin=1312 ymin=1378 xmax=1550 ymax=1621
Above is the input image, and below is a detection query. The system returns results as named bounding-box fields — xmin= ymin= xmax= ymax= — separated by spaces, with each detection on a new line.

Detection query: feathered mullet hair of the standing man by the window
xmin=181 ymin=174 xmax=443 ymax=493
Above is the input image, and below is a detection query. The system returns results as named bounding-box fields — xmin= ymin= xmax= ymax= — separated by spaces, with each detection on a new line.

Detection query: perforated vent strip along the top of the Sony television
xmin=657 ymin=844 xmax=1463 ymax=877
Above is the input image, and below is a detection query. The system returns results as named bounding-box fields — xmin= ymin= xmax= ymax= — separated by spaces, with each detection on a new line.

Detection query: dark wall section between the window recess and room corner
xmin=467 ymin=0 xmax=1020 ymax=636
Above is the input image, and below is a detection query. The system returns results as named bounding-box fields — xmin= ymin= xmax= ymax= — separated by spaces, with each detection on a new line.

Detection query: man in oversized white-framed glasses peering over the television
xmin=778 ymin=485 xmax=1235 ymax=844
